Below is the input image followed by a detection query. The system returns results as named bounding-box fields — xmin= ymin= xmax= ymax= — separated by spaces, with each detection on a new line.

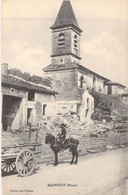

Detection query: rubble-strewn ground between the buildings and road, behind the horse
xmin=2 ymin=112 xmax=128 ymax=163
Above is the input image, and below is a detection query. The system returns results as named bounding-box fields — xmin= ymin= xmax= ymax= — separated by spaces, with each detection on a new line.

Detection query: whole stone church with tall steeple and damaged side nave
xmin=43 ymin=0 xmax=125 ymax=120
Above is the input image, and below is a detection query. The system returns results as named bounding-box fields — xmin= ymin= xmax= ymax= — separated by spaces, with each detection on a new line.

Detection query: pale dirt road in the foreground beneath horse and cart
xmin=2 ymin=148 xmax=128 ymax=195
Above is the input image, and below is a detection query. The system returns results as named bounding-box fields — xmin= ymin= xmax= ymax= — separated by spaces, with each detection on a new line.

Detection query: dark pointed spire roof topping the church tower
xmin=51 ymin=0 xmax=82 ymax=32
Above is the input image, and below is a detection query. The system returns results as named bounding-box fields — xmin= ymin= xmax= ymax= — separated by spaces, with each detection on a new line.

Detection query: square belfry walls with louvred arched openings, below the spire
xmin=51 ymin=28 xmax=80 ymax=64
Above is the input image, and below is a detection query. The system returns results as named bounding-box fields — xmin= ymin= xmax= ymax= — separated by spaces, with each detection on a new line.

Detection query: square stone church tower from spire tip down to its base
xmin=43 ymin=0 xmax=94 ymax=118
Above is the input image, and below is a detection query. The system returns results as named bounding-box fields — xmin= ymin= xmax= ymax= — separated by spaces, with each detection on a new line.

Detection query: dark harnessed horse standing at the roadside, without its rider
xmin=45 ymin=133 xmax=79 ymax=166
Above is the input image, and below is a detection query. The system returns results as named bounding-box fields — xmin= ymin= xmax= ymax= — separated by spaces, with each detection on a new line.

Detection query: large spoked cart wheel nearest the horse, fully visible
xmin=16 ymin=149 xmax=35 ymax=177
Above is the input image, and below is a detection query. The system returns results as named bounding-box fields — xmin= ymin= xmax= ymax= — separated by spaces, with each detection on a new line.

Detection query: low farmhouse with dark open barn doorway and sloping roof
xmin=1 ymin=64 xmax=56 ymax=131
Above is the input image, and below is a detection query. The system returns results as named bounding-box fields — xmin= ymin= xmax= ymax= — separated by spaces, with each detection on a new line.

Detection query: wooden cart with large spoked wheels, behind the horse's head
xmin=1 ymin=126 xmax=41 ymax=177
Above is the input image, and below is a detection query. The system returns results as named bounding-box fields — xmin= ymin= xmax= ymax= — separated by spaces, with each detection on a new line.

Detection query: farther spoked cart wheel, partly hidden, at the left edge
xmin=1 ymin=159 xmax=16 ymax=174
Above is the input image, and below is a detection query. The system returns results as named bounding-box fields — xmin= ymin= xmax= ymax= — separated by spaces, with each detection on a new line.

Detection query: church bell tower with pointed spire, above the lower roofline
xmin=51 ymin=0 xmax=82 ymax=66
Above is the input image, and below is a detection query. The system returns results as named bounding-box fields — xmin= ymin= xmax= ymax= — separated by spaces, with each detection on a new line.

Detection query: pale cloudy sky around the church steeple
xmin=1 ymin=0 xmax=128 ymax=87
